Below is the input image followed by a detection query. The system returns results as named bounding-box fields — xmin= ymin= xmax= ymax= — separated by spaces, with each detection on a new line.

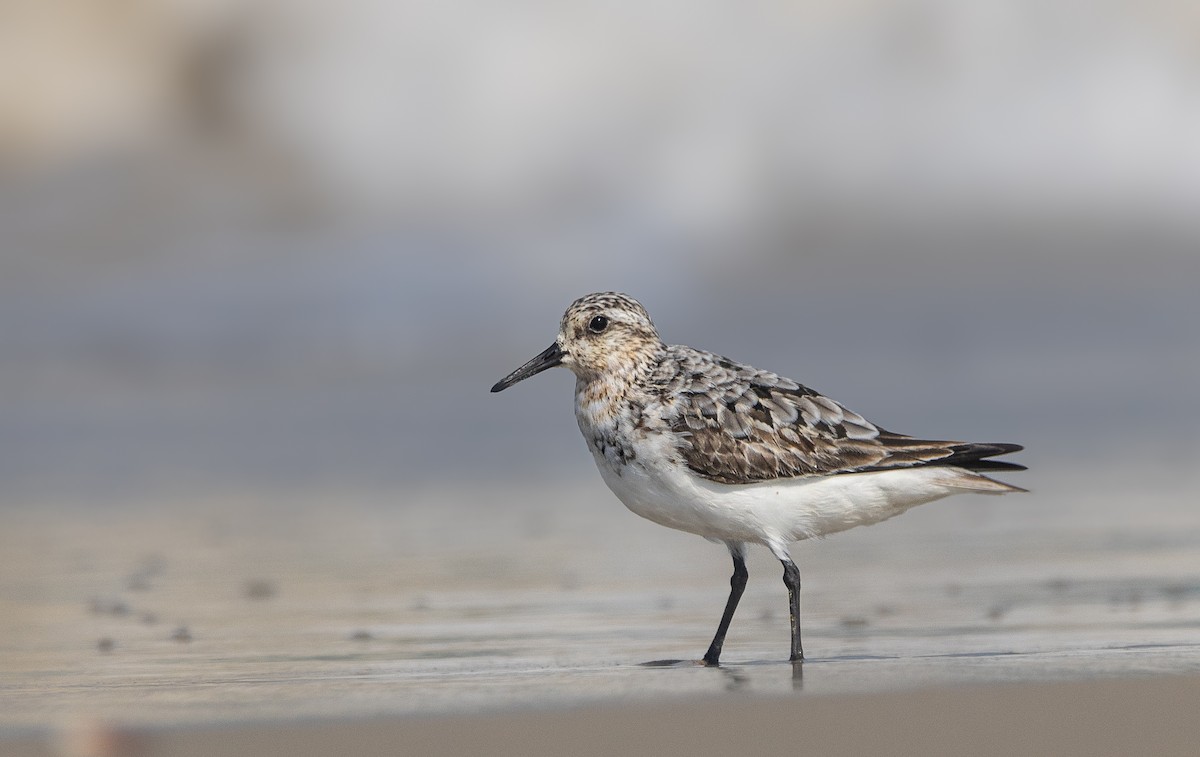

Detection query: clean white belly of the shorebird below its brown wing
xmin=596 ymin=458 xmax=973 ymax=546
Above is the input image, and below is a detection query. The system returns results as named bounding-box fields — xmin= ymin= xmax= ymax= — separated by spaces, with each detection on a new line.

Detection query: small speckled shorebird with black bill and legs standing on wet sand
xmin=492 ymin=292 xmax=1025 ymax=666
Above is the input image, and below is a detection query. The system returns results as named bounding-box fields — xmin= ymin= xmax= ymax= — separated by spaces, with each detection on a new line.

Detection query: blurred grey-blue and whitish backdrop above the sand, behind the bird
xmin=0 ymin=0 xmax=1200 ymax=517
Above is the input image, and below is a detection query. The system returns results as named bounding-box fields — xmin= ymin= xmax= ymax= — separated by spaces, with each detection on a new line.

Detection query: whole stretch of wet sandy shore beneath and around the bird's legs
xmin=0 ymin=476 xmax=1200 ymax=755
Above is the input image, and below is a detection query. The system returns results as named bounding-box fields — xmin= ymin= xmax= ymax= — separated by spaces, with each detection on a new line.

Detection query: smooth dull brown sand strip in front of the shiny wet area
xmin=5 ymin=677 xmax=1200 ymax=757
